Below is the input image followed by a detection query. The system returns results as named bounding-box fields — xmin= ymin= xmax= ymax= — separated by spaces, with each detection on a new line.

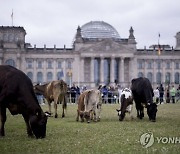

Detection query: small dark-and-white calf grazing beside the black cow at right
xmin=116 ymin=88 xmax=133 ymax=121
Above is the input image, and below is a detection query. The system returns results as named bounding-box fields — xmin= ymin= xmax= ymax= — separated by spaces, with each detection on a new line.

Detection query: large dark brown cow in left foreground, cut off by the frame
xmin=0 ymin=65 xmax=47 ymax=138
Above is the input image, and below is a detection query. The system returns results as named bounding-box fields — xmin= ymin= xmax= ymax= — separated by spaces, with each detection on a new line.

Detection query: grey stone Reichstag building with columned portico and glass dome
xmin=0 ymin=21 xmax=180 ymax=87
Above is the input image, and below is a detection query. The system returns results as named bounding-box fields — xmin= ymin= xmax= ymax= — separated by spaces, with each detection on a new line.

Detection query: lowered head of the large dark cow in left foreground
xmin=29 ymin=113 xmax=47 ymax=139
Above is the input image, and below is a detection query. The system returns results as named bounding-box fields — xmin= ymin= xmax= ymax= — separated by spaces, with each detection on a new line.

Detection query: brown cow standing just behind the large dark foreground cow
xmin=34 ymin=80 xmax=67 ymax=118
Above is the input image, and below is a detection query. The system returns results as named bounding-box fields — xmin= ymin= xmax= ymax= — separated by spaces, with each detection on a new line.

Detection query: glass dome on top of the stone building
xmin=81 ymin=21 xmax=120 ymax=39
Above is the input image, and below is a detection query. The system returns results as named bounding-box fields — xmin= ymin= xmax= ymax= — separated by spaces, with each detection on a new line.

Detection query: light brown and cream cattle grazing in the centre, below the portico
xmin=76 ymin=90 xmax=102 ymax=123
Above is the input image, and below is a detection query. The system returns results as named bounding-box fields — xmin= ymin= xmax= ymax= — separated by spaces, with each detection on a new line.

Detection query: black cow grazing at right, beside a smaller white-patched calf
xmin=131 ymin=77 xmax=157 ymax=122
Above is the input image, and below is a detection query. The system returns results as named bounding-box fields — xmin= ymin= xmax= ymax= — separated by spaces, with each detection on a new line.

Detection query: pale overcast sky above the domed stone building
xmin=0 ymin=0 xmax=180 ymax=48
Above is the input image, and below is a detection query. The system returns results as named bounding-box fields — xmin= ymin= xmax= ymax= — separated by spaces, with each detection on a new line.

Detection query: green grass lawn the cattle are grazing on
xmin=0 ymin=103 xmax=180 ymax=154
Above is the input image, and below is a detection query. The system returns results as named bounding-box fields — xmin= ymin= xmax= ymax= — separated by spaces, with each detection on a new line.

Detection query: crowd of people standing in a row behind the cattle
xmin=37 ymin=81 xmax=180 ymax=105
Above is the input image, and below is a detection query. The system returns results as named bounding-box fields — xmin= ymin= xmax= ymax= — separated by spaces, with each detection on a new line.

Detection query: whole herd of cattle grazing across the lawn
xmin=0 ymin=65 xmax=157 ymax=138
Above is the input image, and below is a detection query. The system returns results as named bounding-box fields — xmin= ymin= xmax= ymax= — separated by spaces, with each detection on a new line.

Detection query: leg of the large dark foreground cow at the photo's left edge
xmin=0 ymin=107 xmax=7 ymax=137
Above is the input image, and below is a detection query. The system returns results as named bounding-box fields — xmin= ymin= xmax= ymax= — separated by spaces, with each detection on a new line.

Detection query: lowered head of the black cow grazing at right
xmin=147 ymin=103 xmax=157 ymax=122
